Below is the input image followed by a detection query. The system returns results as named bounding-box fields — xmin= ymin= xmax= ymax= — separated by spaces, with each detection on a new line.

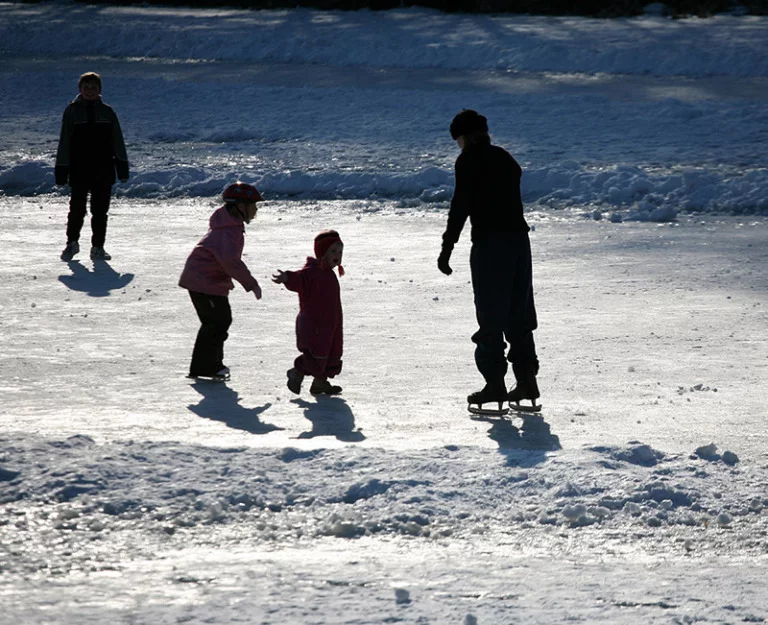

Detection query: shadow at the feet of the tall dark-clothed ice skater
xmin=473 ymin=412 xmax=562 ymax=466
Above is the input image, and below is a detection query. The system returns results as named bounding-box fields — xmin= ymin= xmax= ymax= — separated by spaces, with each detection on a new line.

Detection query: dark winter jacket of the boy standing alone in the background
xmin=54 ymin=95 xmax=128 ymax=186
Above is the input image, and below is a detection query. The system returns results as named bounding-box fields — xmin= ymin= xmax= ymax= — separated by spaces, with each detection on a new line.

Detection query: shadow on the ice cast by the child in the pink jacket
xmin=187 ymin=382 xmax=283 ymax=434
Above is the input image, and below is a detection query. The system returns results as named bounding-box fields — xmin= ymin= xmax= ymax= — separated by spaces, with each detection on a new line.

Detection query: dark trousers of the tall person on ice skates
xmin=470 ymin=232 xmax=539 ymax=385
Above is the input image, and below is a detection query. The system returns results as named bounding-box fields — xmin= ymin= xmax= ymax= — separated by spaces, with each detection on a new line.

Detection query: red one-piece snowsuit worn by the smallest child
xmin=284 ymin=257 xmax=344 ymax=371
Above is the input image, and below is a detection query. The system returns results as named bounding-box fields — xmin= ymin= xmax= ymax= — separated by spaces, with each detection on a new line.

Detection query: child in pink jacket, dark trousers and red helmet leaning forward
xmin=179 ymin=182 xmax=264 ymax=381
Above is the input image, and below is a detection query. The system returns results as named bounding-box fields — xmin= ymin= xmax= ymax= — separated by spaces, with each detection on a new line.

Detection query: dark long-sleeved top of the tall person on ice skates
xmin=443 ymin=142 xmax=530 ymax=249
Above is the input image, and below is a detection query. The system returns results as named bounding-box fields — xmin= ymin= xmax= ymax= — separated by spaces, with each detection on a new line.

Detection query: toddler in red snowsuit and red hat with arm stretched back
xmin=272 ymin=230 xmax=344 ymax=395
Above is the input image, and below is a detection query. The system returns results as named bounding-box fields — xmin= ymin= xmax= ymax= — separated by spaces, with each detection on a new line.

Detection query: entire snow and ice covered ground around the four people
xmin=0 ymin=3 xmax=768 ymax=625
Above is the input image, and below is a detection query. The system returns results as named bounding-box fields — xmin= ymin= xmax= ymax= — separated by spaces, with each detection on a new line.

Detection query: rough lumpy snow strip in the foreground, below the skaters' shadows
xmin=0 ymin=434 xmax=768 ymax=570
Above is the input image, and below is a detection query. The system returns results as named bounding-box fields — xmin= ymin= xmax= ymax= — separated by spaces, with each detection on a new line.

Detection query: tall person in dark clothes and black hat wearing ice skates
xmin=437 ymin=109 xmax=539 ymax=411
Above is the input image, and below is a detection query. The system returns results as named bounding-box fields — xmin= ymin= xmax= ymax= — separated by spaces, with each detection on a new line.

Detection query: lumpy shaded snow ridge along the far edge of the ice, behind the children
xmin=0 ymin=161 xmax=768 ymax=217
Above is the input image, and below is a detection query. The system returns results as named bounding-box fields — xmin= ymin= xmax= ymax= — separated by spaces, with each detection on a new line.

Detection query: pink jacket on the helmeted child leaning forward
xmin=179 ymin=206 xmax=258 ymax=296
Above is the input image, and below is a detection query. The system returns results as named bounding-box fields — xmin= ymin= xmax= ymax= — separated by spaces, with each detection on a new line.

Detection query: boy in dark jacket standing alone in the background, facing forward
xmin=54 ymin=72 xmax=128 ymax=261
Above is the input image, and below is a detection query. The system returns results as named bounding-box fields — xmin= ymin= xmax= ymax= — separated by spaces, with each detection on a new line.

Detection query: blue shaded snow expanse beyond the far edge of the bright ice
xmin=0 ymin=4 xmax=768 ymax=217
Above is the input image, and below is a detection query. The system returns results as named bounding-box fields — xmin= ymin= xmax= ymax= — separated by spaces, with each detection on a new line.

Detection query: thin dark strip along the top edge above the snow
xmin=72 ymin=0 xmax=768 ymax=18
